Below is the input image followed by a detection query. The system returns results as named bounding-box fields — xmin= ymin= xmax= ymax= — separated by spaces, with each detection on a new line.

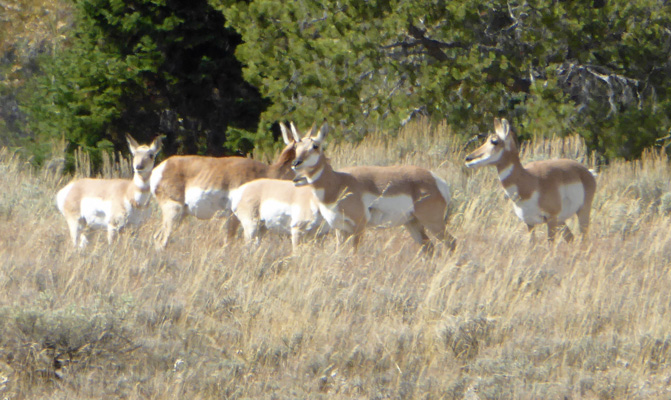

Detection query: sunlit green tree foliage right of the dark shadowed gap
xmin=210 ymin=0 xmax=671 ymax=158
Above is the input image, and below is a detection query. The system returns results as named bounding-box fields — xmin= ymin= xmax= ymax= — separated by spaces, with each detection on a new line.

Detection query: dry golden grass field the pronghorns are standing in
xmin=0 ymin=123 xmax=671 ymax=399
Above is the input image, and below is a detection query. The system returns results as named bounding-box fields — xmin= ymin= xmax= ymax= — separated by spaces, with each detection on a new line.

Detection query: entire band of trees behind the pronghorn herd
xmin=0 ymin=0 xmax=671 ymax=164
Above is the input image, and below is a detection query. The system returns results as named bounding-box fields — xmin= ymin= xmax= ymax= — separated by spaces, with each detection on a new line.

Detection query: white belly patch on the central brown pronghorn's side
xmin=363 ymin=193 xmax=415 ymax=228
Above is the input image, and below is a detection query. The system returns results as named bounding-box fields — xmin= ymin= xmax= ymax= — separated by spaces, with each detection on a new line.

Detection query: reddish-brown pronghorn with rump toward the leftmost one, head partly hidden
xmin=150 ymin=124 xmax=296 ymax=248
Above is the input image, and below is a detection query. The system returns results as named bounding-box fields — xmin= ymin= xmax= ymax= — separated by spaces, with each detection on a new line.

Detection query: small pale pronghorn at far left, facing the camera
xmin=56 ymin=136 xmax=161 ymax=247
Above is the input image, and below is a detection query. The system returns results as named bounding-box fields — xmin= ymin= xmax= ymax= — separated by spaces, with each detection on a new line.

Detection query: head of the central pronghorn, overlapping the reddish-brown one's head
xmin=291 ymin=122 xmax=328 ymax=186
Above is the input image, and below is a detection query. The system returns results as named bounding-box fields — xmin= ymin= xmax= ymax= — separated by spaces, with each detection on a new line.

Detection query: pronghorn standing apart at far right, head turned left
xmin=466 ymin=118 xmax=596 ymax=241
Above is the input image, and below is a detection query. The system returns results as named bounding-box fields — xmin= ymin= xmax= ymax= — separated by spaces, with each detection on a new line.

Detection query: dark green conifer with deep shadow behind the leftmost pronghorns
xmin=24 ymin=0 xmax=266 ymax=169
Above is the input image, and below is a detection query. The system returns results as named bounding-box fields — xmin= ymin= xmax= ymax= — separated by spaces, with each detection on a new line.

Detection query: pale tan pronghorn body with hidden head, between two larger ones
xmin=230 ymin=179 xmax=328 ymax=250
